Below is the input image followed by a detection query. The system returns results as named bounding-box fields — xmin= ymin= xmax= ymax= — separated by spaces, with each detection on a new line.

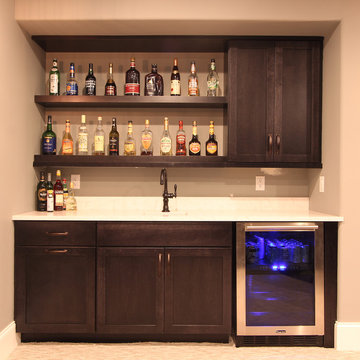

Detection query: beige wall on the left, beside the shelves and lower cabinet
xmin=0 ymin=0 xmax=44 ymax=331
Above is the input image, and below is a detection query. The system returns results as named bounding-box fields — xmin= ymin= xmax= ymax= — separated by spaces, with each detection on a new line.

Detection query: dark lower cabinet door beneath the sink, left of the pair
xmin=97 ymin=247 xmax=164 ymax=334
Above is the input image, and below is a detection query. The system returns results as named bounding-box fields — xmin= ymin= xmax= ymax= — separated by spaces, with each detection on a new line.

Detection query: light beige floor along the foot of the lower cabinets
xmin=9 ymin=343 xmax=360 ymax=360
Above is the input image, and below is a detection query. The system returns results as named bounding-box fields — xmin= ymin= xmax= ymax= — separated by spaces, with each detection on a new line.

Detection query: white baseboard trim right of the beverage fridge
xmin=335 ymin=321 xmax=360 ymax=351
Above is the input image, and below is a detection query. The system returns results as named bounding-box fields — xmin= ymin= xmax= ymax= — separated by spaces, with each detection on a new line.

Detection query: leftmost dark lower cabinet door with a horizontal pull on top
xmin=15 ymin=246 xmax=95 ymax=333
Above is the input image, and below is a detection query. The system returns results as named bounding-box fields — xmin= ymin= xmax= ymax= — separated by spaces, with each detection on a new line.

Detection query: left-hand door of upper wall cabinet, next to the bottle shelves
xmin=228 ymin=41 xmax=275 ymax=163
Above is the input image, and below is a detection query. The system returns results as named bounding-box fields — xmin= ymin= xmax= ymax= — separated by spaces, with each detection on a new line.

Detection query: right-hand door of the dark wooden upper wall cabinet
xmin=274 ymin=41 xmax=322 ymax=164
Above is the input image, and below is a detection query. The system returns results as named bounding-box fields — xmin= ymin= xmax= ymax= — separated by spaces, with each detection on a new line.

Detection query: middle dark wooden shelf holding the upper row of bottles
xmin=34 ymin=95 xmax=227 ymax=108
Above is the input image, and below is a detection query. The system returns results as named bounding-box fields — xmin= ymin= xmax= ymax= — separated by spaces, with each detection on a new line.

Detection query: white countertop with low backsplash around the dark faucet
xmin=12 ymin=197 xmax=344 ymax=222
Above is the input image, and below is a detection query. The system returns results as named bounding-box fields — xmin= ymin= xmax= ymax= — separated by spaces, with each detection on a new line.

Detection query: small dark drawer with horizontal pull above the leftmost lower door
xmin=15 ymin=221 xmax=96 ymax=246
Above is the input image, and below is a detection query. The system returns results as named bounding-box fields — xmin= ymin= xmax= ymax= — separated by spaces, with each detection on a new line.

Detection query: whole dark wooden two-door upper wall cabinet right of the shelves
xmin=228 ymin=40 xmax=322 ymax=167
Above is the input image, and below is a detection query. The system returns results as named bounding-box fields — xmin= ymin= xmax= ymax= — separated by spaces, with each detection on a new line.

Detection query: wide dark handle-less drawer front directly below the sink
xmin=97 ymin=222 xmax=232 ymax=247
